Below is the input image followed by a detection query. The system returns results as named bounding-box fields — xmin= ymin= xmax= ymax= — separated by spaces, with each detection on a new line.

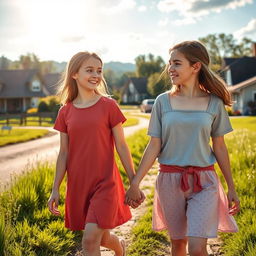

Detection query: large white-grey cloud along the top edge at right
xmin=157 ymin=0 xmax=253 ymax=25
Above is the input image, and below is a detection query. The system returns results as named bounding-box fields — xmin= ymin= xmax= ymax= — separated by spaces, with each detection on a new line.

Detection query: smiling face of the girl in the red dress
xmin=72 ymin=57 xmax=102 ymax=91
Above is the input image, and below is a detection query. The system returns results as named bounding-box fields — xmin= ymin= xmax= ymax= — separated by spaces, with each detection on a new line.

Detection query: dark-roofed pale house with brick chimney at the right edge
xmin=220 ymin=43 xmax=256 ymax=115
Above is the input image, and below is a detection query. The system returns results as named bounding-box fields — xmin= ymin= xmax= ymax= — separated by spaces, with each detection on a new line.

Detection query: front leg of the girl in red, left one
xmin=82 ymin=223 xmax=105 ymax=256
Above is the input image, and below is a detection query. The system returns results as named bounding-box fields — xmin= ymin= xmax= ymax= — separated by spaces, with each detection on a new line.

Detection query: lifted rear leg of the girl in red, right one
xmin=101 ymin=230 xmax=124 ymax=256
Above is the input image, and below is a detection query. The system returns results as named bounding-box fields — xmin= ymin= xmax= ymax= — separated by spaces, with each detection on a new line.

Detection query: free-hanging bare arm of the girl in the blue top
xmin=212 ymin=136 xmax=239 ymax=214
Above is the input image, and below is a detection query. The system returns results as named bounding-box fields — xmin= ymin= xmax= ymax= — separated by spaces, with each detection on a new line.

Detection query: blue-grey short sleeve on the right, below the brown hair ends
xmin=211 ymin=100 xmax=233 ymax=137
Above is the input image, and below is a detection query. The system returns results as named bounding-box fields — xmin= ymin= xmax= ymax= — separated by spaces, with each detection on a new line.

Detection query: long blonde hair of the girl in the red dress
xmin=57 ymin=51 xmax=109 ymax=105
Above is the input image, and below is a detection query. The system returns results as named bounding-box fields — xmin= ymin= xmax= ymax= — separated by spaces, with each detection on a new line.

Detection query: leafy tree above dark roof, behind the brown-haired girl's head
xmin=199 ymin=33 xmax=253 ymax=69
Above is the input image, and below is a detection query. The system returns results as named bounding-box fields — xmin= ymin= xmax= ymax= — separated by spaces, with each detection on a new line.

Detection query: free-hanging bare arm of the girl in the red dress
xmin=48 ymin=132 xmax=68 ymax=215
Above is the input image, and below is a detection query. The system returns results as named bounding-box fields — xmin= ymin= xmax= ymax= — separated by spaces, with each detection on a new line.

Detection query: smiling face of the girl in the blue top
xmin=168 ymin=50 xmax=195 ymax=85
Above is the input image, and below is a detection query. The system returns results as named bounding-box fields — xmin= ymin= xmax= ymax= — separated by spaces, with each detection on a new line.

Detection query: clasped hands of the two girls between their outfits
xmin=124 ymin=184 xmax=145 ymax=209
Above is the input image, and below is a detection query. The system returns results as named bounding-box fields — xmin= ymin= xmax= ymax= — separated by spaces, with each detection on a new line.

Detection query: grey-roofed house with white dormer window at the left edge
xmin=0 ymin=69 xmax=60 ymax=113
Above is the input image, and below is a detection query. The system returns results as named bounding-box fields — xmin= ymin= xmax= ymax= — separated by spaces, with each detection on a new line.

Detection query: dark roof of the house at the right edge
xmin=221 ymin=57 xmax=256 ymax=84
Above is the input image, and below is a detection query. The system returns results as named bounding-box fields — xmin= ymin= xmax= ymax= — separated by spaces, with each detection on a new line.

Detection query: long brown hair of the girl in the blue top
xmin=164 ymin=41 xmax=232 ymax=106
